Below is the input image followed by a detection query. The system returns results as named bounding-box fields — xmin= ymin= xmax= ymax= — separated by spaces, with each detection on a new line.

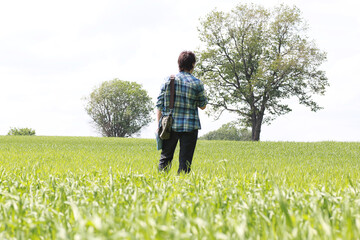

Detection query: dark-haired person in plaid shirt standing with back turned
xmin=156 ymin=51 xmax=207 ymax=174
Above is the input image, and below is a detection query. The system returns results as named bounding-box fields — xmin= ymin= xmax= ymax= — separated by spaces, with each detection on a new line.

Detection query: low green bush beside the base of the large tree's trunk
xmin=200 ymin=122 xmax=251 ymax=141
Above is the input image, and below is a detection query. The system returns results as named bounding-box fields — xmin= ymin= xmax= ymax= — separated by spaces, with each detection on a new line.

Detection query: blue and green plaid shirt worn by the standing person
xmin=156 ymin=72 xmax=208 ymax=132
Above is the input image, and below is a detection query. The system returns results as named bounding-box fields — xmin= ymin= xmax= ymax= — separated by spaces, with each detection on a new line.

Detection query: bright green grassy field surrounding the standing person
xmin=0 ymin=136 xmax=360 ymax=239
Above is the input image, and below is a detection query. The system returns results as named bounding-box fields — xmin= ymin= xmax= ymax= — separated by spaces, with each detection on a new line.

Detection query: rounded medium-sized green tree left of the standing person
xmin=85 ymin=79 xmax=153 ymax=137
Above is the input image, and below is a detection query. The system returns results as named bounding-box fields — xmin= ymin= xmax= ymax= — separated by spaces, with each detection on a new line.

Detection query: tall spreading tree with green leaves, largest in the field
xmin=197 ymin=4 xmax=329 ymax=141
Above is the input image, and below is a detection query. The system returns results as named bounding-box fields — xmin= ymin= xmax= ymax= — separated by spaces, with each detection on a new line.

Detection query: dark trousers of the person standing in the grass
xmin=159 ymin=130 xmax=198 ymax=174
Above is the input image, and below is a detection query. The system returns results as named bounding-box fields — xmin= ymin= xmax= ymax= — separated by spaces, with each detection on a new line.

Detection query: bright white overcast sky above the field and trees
xmin=0 ymin=0 xmax=360 ymax=141
